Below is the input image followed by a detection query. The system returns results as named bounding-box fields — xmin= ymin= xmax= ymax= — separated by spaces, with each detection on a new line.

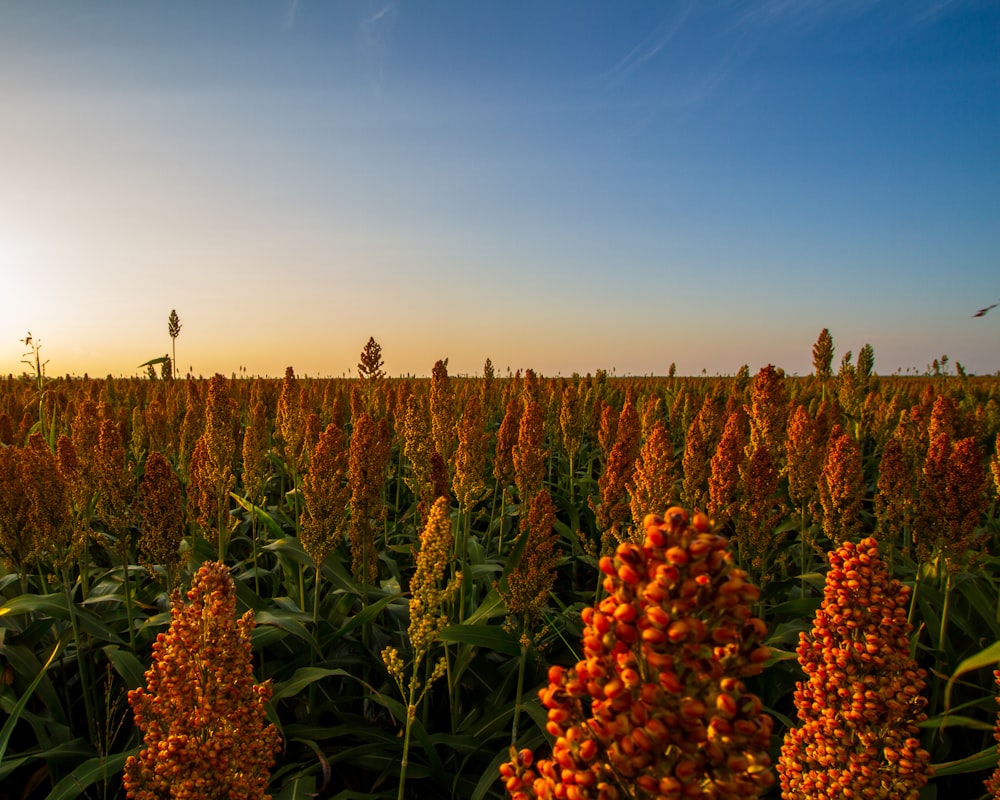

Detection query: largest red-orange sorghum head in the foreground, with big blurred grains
xmin=500 ymin=508 xmax=774 ymax=800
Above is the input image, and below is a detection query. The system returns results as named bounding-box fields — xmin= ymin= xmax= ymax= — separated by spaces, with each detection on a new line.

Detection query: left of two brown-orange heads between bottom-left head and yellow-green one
xmin=299 ymin=422 xmax=351 ymax=567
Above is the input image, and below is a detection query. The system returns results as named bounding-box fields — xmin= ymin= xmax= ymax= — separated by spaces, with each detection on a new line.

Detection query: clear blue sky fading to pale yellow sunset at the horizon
xmin=0 ymin=0 xmax=1000 ymax=375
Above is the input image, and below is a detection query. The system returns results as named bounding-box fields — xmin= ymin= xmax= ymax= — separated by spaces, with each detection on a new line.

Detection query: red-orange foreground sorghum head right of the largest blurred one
xmin=778 ymin=538 xmax=930 ymax=800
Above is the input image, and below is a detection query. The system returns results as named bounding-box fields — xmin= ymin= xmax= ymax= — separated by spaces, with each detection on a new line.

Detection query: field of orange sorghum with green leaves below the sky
xmin=0 ymin=341 xmax=1000 ymax=800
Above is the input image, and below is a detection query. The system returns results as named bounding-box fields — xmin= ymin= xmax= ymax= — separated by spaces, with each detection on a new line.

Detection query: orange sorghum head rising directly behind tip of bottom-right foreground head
xmin=819 ymin=429 xmax=865 ymax=544
